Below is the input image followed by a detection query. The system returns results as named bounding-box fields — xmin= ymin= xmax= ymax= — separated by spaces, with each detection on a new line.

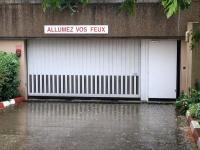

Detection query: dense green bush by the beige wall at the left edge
xmin=0 ymin=52 xmax=19 ymax=100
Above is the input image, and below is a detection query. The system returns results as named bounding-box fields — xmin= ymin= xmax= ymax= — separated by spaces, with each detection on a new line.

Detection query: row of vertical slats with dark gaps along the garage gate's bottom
xmin=29 ymin=74 xmax=139 ymax=97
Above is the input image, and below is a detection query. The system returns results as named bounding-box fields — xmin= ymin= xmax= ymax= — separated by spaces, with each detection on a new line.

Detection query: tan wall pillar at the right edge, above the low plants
xmin=181 ymin=22 xmax=200 ymax=92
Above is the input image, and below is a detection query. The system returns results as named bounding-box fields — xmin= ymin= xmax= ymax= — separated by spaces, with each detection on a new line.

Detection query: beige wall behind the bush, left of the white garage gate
xmin=0 ymin=40 xmax=27 ymax=97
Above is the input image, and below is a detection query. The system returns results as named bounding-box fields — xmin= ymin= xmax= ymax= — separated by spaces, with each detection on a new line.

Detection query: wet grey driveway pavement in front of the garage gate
xmin=0 ymin=103 xmax=195 ymax=150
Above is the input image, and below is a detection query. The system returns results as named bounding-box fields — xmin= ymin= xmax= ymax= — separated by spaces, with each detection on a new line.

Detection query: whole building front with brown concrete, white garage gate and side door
xmin=0 ymin=0 xmax=200 ymax=101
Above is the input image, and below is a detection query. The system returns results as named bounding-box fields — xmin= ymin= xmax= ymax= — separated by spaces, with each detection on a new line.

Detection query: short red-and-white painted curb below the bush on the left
xmin=0 ymin=97 xmax=25 ymax=109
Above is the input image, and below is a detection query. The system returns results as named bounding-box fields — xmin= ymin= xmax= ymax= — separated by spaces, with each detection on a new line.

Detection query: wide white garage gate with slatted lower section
xmin=27 ymin=38 xmax=140 ymax=98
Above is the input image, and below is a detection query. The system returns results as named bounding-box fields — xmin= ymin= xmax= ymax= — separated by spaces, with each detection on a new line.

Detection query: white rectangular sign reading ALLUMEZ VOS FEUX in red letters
xmin=44 ymin=25 xmax=108 ymax=34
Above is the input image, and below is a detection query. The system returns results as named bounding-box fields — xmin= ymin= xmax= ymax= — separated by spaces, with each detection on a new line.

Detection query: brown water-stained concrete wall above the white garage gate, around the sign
xmin=0 ymin=2 xmax=200 ymax=38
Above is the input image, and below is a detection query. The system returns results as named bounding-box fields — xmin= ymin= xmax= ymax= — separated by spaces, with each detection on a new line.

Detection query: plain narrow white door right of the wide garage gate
xmin=149 ymin=40 xmax=177 ymax=99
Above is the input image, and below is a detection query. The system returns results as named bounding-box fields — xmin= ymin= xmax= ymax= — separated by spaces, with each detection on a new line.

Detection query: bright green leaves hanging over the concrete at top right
xmin=161 ymin=0 xmax=192 ymax=18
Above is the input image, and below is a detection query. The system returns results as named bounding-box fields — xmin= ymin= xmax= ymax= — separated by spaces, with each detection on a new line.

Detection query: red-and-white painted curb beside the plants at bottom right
xmin=186 ymin=111 xmax=200 ymax=149
